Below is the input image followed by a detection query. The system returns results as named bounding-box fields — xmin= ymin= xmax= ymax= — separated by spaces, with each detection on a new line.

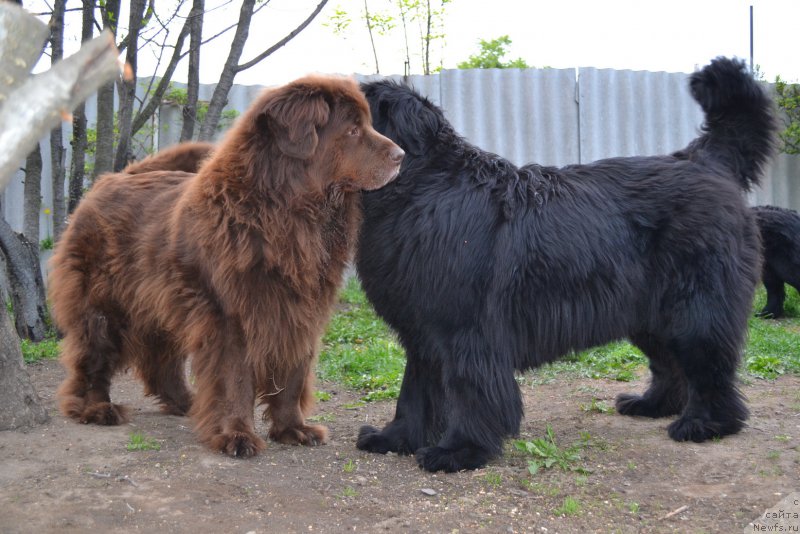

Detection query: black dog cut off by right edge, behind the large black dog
xmin=753 ymin=206 xmax=800 ymax=319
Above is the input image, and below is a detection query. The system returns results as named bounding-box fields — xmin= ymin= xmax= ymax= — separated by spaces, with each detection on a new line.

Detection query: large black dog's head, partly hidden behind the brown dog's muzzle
xmin=361 ymin=80 xmax=451 ymax=156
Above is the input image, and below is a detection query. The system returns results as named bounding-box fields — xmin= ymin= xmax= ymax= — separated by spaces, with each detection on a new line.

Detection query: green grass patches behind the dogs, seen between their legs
xmin=22 ymin=278 xmax=800 ymax=406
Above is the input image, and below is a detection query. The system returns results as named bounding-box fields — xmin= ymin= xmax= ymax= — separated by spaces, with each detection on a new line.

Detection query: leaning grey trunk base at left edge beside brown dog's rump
xmin=0 ymin=219 xmax=47 ymax=341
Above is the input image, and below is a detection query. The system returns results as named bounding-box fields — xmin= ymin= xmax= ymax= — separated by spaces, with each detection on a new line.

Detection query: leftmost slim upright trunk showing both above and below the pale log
xmin=48 ymin=0 xmax=67 ymax=243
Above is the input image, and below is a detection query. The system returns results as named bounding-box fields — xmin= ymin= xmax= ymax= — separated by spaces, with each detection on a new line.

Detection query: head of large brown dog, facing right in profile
xmin=228 ymin=76 xmax=405 ymax=194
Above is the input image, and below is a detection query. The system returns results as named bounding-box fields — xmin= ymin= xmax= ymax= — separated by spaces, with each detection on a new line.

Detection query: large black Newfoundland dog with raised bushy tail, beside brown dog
xmin=357 ymin=58 xmax=775 ymax=471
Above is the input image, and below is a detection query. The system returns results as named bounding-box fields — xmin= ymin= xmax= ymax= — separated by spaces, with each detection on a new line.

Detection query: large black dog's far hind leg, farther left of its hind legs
xmin=616 ymin=334 xmax=688 ymax=417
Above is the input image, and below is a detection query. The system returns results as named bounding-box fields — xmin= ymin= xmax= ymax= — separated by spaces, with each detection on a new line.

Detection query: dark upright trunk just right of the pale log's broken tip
xmin=114 ymin=0 xmax=147 ymax=172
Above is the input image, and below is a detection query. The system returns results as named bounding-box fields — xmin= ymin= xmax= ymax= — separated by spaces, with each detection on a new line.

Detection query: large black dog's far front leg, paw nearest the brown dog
xmin=356 ymin=351 xmax=444 ymax=454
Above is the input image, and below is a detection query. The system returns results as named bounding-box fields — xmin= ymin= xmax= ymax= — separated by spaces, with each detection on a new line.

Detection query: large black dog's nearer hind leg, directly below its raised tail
xmin=667 ymin=338 xmax=748 ymax=443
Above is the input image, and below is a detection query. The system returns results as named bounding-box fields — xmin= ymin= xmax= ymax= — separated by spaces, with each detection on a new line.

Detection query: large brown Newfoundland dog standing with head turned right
xmin=49 ymin=76 xmax=404 ymax=457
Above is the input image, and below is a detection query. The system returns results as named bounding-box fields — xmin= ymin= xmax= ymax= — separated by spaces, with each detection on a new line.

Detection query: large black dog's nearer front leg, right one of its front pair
xmin=415 ymin=334 xmax=523 ymax=472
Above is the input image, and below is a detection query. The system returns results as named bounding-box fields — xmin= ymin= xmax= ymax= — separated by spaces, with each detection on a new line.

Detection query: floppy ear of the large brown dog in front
xmin=264 ymin=85 xmax=330 ymax=159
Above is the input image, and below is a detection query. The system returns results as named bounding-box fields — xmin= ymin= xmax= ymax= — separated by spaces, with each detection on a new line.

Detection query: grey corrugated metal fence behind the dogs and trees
xmin=2 ymin=68 xmax=800 ymax=244
